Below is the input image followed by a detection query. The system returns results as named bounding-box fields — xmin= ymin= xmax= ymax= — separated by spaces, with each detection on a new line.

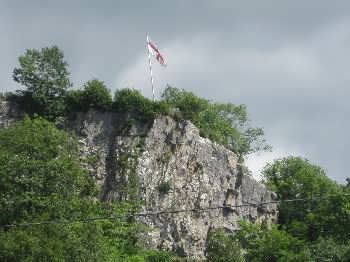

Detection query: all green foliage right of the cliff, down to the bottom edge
xmin=208 ymin=157 xmax=350 ymax=262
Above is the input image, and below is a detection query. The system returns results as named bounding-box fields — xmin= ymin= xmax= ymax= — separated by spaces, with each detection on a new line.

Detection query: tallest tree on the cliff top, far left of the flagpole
xmin=13 ymin=46 xmax=72 ymax=119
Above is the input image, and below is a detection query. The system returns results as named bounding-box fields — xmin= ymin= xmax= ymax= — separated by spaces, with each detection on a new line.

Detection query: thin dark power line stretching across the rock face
xmin=0 ymin=198 xmax=315 ymax=228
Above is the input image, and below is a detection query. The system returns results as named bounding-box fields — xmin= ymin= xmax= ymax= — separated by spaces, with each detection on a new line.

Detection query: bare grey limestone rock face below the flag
xmin=0 ymin=102 xmax=277 ymax=258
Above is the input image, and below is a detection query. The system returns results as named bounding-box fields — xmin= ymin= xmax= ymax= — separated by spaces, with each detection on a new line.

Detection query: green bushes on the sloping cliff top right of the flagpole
xmin=162 ymin=86 xmax=270 ymax=156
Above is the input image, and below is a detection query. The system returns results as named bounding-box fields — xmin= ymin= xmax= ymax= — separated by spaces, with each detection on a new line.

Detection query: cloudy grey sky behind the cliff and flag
xmin=0 ymin=0 xmax=350 ymax=183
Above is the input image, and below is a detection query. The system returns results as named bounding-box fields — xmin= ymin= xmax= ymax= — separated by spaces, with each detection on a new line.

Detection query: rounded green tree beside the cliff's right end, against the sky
xmin=263 ymin=157 xmax=350 ymax=242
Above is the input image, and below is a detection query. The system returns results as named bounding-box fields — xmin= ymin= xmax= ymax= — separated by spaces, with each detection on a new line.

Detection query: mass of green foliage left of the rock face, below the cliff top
xmin=0 ymin=118 xmax=175 ymax=261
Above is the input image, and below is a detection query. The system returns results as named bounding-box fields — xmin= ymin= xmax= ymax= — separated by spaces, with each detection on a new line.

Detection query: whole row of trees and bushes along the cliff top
xmin=9 ymin=46 xmax=270 ymax=159
